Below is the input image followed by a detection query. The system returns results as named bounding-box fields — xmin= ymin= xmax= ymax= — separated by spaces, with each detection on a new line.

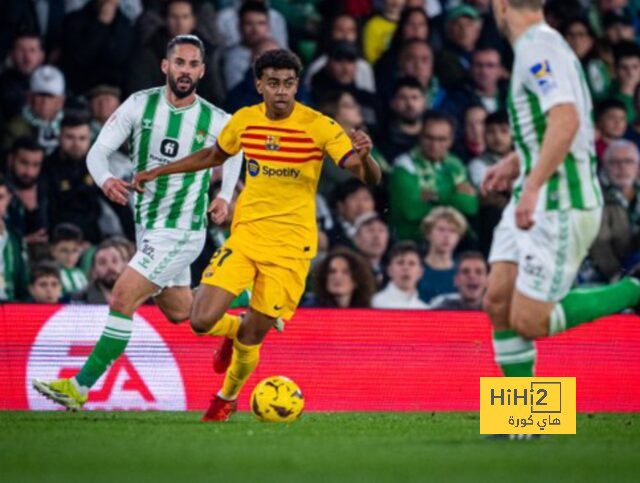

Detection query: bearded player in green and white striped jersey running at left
xmin=33 ymin=35 xmax=242 ymax=409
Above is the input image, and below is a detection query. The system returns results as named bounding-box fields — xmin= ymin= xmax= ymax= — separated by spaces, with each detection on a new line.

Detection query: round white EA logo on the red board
xmin=26 ymin=305 xmax=187 ymax=411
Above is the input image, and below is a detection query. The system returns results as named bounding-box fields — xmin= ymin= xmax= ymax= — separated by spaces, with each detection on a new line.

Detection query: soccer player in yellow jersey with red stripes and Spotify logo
xmin=134 ymin=50 xmax=381 ymax=421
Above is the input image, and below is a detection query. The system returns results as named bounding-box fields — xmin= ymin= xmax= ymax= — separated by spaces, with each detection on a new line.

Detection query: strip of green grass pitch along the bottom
xmin=0 ymin=411 xmax=640 ymax=483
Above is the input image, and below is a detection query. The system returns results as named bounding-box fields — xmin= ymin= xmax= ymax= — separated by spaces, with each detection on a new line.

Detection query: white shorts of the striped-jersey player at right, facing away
xmin=489 ymin=202 xmax=602 ymax=302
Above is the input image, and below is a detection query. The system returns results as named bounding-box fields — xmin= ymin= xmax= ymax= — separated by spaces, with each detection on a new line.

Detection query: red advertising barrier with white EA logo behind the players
xmin=0 ymin=305 xmax=640 ymax=412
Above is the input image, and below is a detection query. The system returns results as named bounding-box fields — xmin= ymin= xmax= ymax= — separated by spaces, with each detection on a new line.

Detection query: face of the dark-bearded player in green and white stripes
xmin=162 ymin=44 xmax=204 ymax=99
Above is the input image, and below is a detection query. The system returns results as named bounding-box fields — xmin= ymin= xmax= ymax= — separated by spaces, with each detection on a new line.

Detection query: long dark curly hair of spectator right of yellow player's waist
xmin=313 ymin=248 xmax=376 ymax=308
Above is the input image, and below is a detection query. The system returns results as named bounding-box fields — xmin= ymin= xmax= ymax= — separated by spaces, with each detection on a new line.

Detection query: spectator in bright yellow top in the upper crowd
xmin=362 ymin=0 xmax=406 ymax=65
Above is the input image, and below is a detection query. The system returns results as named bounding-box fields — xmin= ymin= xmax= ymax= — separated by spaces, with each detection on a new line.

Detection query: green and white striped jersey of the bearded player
xmin=88 ymin=86 xmax=242 ymax=230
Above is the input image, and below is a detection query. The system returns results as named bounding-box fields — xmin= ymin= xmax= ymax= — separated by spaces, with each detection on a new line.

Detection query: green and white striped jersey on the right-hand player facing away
xmin=507 ymin=22 xmax=602 ymax=211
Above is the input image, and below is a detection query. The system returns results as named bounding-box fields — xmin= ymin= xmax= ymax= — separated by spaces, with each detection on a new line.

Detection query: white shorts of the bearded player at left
xmin=129 ymin=225 xmax=206 ymax=288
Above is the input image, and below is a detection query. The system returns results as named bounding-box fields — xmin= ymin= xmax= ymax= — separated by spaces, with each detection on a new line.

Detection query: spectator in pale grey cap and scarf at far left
xmin=2 ymin=65 xmax=65 ymax=154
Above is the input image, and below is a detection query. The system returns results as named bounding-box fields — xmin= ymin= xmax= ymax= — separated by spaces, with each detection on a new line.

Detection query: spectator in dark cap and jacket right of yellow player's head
xmin=311 ymin=41 xmax=380 ymax=129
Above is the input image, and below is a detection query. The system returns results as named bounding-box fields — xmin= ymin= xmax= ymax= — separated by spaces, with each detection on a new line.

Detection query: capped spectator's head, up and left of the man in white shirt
xmin=353 ymin=211 xmax=389 ymax=287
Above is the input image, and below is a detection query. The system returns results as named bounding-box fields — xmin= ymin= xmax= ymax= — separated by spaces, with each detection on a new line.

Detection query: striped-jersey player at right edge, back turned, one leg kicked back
xmin=483 ymin=0 xmax=640 ymax=377
